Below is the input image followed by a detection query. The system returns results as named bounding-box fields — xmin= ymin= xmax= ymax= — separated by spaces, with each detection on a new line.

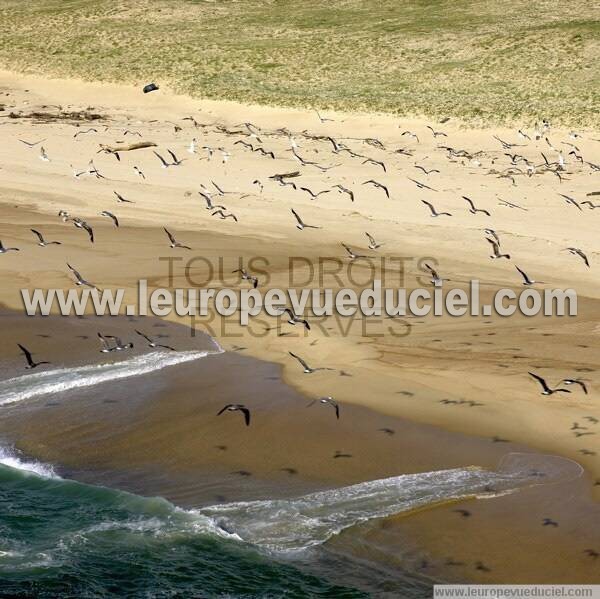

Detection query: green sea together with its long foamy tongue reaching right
xmin=0 ymin=448 xmax=572 ymax=598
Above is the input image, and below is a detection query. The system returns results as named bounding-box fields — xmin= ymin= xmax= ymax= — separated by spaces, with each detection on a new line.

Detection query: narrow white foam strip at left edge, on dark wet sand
xmin=0 ymin=348 xmax=223 ymax=405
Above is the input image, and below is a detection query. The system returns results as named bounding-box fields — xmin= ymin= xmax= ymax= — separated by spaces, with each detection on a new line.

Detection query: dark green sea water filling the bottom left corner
xmin=0 ymin=465 xmax=368 ymax=599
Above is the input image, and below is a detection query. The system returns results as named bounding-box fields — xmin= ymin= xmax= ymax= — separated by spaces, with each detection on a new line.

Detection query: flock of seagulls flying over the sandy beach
xmin=0 ymin=84 xmax=600 ymax=571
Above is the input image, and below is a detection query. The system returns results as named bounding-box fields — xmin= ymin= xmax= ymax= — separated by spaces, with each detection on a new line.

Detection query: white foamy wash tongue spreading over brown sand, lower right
xmin=196 ymin=468 xmax=528 ymax=552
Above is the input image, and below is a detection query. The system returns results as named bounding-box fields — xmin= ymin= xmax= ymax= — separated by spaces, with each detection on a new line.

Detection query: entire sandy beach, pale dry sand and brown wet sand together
xmin=0 ymin=67 xmax=600 ymax=583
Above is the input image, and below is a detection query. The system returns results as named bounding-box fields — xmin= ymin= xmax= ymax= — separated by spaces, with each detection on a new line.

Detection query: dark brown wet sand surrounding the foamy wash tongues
xmin=0 ymin=313 xmax=600 ymax=583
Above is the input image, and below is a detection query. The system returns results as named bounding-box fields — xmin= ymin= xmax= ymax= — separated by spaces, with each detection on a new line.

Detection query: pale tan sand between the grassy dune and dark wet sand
xmin=0 ymin=73 xmax=600 ymax=582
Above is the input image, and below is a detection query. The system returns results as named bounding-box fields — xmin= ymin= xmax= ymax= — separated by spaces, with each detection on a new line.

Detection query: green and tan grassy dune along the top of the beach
xmin=0 ymin=0 xmax=600 ymax=126
